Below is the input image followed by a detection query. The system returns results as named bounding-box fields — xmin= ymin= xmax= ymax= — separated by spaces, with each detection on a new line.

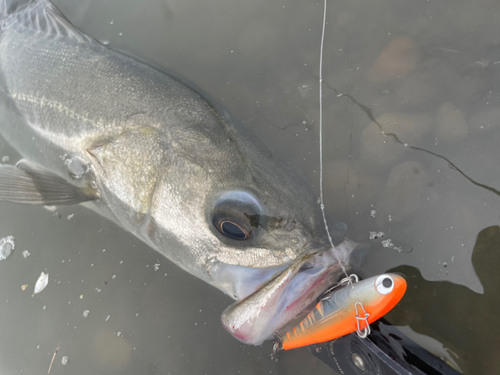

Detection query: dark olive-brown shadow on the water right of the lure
xmin=386 ymin=226 xmax=500 ymax=374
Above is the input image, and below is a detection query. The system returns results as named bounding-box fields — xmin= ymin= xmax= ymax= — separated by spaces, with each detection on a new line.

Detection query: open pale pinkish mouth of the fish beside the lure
xmin=221 ymin=240 xmax=354 ymax=345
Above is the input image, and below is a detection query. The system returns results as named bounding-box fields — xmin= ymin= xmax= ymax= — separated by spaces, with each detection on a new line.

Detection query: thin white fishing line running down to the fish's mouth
xmin=319 ymin=0 xmax=349 ymax=277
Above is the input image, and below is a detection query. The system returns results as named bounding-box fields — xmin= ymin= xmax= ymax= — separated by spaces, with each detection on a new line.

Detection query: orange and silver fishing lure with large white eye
xmin=281 ymin=274 xmax=406 ymax=350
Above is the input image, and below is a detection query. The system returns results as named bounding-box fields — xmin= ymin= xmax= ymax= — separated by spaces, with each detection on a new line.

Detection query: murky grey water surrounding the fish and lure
xmin=0 ymin=0 xmax=500 ymax=374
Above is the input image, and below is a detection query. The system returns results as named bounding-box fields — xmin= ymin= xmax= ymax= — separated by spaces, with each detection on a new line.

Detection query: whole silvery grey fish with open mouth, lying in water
xmin=0 ymin=0 xmax=364 ymax=345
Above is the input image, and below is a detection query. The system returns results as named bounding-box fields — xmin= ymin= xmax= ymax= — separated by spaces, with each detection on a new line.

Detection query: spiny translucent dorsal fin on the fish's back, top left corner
xmin=0 ymin=0 xmax=93 ymax=42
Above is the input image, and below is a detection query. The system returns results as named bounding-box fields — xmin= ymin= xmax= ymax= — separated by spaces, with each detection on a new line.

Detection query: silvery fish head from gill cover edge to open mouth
xmin=89 ymin=104 xmax=352 ymax=344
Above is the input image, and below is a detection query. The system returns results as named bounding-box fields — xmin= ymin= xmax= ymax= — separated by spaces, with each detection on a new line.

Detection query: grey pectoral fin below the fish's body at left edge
xmin=0 ymin=163 xmax=99 ymax=205
